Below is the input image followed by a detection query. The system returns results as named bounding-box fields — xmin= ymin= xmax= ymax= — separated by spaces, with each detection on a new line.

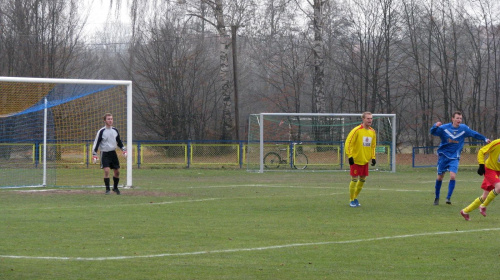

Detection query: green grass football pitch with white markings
xmin=0 ymin=168 xmax=500 ymax=280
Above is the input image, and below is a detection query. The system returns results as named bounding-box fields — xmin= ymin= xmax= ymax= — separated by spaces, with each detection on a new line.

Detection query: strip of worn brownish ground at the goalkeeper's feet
xmin=17 ymin=188 xmax=189 ymax=197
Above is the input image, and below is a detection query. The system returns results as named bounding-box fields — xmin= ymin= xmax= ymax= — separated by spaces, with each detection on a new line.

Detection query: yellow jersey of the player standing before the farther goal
xmin=345 ymin=124 xmax=377 ymax=165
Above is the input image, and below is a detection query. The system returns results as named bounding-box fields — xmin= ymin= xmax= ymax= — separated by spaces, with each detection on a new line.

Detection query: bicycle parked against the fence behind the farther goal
xmin=264 ymin=143 xmax=308 ymax=169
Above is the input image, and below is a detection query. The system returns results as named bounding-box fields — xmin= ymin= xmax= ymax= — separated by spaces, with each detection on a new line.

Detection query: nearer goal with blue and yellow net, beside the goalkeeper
xmin=0 ymin=77 xmax=133 ymax=188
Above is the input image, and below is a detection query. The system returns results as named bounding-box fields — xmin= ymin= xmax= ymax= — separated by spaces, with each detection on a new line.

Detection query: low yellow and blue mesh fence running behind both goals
xmin=0 ymin=140 xmax=391 ymax=170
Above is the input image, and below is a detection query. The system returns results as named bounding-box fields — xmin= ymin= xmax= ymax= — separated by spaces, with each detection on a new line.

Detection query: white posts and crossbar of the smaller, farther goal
xmin=258 ymin=113 xmax=396 ymax=173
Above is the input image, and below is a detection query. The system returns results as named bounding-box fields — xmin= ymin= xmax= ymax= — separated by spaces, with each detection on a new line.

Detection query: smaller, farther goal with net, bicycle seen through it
xmin=245 ymin=113 xmax=396 ymax=173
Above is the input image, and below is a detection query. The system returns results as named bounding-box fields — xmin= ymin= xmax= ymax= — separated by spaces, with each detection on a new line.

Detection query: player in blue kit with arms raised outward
xmin=431 ymin=111 xmax=491 ymax=205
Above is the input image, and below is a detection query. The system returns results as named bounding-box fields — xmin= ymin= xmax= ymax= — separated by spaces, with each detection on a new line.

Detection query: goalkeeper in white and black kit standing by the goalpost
xmin=92 ymin=113 xmax=127 ymax=194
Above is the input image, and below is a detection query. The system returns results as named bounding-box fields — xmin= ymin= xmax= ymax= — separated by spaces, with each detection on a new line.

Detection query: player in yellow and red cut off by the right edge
xmin=460 ymin=139 xmax=500 ymax=221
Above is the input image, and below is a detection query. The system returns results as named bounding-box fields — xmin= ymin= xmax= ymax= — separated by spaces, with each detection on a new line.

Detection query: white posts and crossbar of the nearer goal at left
xmin=0 ymin=76 xmax=134 ymax=187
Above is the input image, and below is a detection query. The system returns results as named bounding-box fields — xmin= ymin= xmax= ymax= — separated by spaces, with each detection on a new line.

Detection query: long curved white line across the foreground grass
xmin=0 ymin=228 xmax=500 ymax=261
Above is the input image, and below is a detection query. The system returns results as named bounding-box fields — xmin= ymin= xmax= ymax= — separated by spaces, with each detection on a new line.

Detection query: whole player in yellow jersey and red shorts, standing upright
xmin=345 ymin=112 xmax=377 ymax=207
